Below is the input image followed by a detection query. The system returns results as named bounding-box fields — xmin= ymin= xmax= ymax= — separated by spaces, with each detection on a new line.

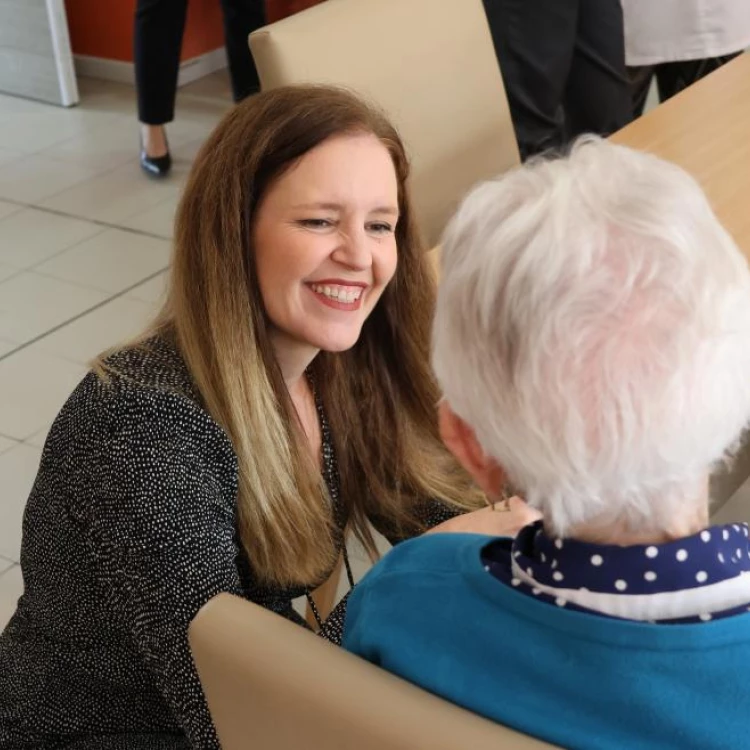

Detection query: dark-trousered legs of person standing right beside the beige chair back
xmin=484 ymin=0 xmax=632 ymax=159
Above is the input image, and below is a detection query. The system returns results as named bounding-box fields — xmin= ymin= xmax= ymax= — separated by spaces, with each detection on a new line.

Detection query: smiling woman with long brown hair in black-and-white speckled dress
xmin=0 ymin=87 xmax=494 ymax=750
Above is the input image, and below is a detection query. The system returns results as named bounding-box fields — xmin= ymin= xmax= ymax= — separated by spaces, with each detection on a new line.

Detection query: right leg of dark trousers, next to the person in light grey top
xmin=564 ymin=0 xmax=633 ymax=140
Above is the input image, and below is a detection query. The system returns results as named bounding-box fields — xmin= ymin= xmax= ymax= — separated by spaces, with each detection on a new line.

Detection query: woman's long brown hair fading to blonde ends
xmin=103 ymin=86 xmax=477 ymax=585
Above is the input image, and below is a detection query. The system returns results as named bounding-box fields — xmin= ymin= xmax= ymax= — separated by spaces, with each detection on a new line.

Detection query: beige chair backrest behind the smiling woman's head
xmin=250 ymin=0 xmax=519 ymax=245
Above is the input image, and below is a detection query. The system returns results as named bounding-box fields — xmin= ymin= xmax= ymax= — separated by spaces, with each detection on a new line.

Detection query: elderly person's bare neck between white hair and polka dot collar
xmin=566 ymin=488 xmax=709 ymax=547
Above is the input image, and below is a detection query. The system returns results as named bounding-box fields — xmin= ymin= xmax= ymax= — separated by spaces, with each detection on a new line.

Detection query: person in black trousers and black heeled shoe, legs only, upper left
xmin=134 ymin=0 xmax=266 ymax=177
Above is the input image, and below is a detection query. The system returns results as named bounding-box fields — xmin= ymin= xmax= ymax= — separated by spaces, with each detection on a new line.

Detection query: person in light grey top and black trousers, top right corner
xmin=622 ymin=0 xmax=750 ymax=117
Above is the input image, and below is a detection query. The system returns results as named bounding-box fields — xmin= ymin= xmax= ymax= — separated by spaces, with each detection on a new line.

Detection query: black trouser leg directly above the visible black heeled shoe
xmin=134 ymin=0 xmax=187 ymax=125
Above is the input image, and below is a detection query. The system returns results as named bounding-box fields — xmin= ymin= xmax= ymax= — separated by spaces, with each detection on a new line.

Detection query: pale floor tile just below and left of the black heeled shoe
xmin=40 ymin=162 xmax=180 ymax=224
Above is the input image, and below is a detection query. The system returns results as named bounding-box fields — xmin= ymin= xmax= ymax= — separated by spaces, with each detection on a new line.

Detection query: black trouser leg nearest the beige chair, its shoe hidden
xmin=221 ymin=0 xmax=266 ymax=102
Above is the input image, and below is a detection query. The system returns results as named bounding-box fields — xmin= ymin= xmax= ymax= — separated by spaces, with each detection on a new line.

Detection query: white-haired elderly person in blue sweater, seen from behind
xmin=344 ymin=139 xmax=750 ymax=750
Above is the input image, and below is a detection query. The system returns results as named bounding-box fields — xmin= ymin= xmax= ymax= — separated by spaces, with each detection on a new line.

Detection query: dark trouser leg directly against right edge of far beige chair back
xmin=484 ymin=0 xmax=579 ymax=159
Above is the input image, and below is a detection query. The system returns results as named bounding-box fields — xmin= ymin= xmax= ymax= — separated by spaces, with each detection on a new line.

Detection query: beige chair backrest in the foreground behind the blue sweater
xmin=190 ymin=594 xmax=552 ymax=750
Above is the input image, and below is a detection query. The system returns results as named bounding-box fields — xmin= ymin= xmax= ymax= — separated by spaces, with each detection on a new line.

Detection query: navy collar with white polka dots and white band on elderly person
xmin=482 ymin=521 xmax=750 ymax=622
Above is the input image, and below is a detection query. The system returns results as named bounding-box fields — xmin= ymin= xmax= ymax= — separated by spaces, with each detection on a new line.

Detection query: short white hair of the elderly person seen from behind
xmin=433 ymin=136 xmax=750 ymax=536
